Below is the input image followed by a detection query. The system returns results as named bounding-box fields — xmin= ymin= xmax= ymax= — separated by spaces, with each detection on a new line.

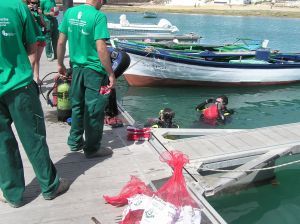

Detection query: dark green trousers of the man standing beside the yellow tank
xmin=68 ymin=68 xmax=109 ymax=155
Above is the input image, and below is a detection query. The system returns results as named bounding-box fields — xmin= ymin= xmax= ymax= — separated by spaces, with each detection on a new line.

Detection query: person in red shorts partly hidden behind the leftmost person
xmin=26 ymin=0 xmax=47 ymax=85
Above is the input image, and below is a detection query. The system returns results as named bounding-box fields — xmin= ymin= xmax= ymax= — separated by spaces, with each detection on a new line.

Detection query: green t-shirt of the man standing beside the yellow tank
xmin=59 ymin=5 xmax=110 ymax=74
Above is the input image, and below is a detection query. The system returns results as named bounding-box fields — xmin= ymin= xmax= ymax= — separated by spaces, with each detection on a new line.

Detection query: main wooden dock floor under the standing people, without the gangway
xmin=0 ymin=55 xmax=171 ymax=224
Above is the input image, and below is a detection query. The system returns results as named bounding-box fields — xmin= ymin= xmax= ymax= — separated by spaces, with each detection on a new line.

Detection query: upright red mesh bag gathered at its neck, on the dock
xmin=155 ymin=151 xmax=199 ymax=208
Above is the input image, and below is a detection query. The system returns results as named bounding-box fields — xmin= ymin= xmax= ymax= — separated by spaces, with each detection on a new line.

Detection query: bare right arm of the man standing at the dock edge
xmin=96 ymin=40 xmax=116 ymax=89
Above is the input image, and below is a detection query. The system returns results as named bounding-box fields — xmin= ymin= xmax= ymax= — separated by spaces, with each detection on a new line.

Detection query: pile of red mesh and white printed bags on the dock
xmin=103 ymin=151 xmax=201 ymax=224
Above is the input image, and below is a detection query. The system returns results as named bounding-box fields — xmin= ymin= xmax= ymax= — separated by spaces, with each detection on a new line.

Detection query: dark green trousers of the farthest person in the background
xmin=45 ymin=18 xmax=59 ymax=59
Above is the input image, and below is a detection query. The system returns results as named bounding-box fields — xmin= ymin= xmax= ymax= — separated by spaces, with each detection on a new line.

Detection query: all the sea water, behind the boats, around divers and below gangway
xmin=107 ymin=13 xmax=300 ymax=224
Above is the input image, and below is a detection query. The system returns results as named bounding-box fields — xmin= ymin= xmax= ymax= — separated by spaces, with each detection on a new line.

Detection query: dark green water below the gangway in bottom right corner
xmin=209 ymin=156 xmax=300 ymax=224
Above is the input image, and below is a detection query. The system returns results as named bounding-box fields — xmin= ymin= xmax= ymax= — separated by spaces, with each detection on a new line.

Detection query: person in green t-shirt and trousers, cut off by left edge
xmin=0 ymin=0 xmax=70 ymax=207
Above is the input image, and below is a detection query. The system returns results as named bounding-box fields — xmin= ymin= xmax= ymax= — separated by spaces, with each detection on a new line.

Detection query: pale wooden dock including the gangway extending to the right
xmin=0 ymin=53 xmax=300 ymax=224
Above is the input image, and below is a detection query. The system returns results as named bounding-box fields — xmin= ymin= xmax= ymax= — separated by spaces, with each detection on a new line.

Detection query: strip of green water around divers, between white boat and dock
xmin=115 ymin=80 xmax=300 ymax=128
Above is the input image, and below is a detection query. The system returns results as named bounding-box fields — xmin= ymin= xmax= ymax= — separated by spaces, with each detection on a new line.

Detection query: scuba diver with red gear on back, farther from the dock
xmin=196 ymin=95 xmax=234 ymax=125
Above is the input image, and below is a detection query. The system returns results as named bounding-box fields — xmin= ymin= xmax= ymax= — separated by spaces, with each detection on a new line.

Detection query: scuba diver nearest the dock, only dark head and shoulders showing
xmin=145 ymin=108 xmax=179 ymax=128
